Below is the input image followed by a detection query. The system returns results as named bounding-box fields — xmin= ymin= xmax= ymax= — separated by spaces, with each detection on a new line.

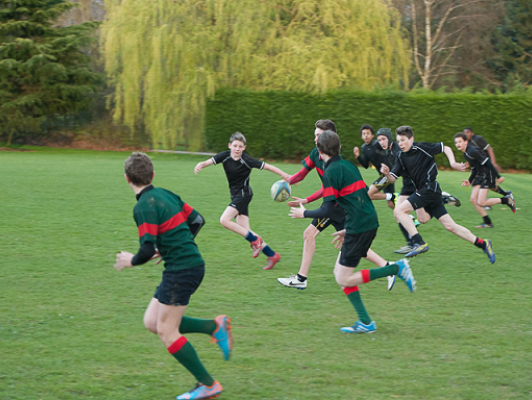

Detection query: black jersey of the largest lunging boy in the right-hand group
xmin=390 ymin=142 xmax=444 ymax=190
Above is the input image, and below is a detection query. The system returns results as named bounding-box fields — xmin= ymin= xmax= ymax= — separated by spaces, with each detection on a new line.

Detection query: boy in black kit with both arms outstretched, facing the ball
xmin=194 ymin=132 xmax=290 ymax=269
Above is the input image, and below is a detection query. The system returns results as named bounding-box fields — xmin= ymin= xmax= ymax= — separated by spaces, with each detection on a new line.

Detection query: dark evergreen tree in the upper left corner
xmin=0 ymin=0 xmax=101 ymax=145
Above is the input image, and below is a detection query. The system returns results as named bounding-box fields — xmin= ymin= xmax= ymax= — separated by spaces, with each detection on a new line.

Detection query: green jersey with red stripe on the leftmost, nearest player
xmin=133 ymin=185 xmax=205 ymax=271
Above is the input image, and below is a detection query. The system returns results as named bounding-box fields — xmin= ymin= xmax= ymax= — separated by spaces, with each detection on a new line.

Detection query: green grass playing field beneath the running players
xmin=0 ymin=149 xmax=532 ymax=400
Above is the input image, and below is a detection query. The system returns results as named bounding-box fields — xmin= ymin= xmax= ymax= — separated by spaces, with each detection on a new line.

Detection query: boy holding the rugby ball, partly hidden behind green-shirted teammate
xmin=277 ymin=119 xmax=352 ymax=290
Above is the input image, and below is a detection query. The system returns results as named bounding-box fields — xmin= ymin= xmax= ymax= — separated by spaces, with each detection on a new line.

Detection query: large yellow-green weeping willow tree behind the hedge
xmin=102 ymin=0 xmax=409 ymax=149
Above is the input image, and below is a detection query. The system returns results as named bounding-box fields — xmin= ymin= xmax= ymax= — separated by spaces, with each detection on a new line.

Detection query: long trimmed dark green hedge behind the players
xmin=205 ymin=89 xmax=532 ymax=170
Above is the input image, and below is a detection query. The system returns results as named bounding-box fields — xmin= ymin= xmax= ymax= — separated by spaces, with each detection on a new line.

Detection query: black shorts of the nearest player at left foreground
xmin=153 ymin=265 xmax=205 ymax=306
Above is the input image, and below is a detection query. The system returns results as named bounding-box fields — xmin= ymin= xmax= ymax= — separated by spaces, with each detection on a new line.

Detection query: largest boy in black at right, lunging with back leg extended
xmin=381 ymin=126 xmax=495 ymax=264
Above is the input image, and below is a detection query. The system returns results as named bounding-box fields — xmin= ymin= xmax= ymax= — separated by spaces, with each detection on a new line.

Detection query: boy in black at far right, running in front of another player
xmin=454 ymin=132 xmax=515 ymax=228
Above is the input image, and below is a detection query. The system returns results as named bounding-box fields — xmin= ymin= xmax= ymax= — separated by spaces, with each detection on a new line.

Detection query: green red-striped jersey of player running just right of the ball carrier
xmin=323 ymin=156 xmax=379 ymax=233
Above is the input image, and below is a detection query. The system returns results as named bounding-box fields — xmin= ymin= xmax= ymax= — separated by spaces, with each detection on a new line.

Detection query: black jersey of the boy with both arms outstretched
xmin=212 ymin=150 xmax=264 ymax=196
